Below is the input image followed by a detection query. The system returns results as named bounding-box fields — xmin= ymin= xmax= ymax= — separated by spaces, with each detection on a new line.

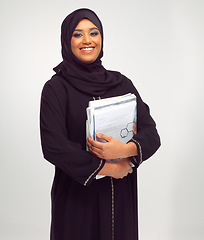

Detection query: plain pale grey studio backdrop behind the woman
xmin=0 ymin=0 xmax=204 ymax=240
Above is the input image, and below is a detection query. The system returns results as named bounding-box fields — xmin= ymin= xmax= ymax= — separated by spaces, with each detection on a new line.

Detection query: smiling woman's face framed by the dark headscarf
xmin=71 ymin=19 xmax=101 ymax=64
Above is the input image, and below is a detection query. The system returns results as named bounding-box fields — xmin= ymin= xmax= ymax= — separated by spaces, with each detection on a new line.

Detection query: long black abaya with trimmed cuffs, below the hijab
xmin=41 ymin=75 xmax=160 ymax=240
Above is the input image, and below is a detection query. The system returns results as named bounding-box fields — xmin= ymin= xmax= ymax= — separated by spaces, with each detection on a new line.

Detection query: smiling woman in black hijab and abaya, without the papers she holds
xmin=40 ymin=9 xmax=160 ymax=240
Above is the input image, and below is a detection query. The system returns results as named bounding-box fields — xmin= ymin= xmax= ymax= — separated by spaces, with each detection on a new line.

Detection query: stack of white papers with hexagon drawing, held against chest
xmin=86 ymin=93 xmax=136 ymax=180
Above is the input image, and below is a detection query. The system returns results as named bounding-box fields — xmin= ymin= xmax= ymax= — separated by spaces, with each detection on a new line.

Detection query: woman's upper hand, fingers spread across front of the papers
xmin=87 ymin=133 xmax=127 ymax=160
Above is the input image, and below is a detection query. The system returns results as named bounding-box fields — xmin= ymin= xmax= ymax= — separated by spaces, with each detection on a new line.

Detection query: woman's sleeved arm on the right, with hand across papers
xmin=87 ymin=80 xmax=160 ymax=167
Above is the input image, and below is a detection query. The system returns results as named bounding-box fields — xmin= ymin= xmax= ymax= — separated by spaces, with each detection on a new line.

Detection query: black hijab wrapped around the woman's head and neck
xmin=54 ymin=8 xmax=122 ymax=97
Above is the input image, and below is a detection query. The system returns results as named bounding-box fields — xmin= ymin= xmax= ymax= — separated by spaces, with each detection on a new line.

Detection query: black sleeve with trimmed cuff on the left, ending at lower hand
xmin=40 ymin=81 xmax=104 ymax=185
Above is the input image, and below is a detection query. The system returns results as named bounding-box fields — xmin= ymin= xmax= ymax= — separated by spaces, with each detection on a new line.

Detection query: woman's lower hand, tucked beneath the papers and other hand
xmin=98 ymin=158 xmax=133 ymax=179
